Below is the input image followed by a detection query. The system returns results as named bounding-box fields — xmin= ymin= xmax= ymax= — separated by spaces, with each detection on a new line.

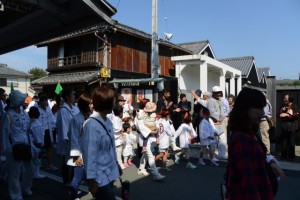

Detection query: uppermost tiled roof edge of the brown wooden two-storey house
xmin=36 ymin=21 xmax=192 ymax=54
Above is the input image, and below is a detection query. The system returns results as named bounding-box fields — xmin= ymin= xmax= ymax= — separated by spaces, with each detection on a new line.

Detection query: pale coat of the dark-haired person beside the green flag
xmin=56 ymin=103 xmax=77 ymax=155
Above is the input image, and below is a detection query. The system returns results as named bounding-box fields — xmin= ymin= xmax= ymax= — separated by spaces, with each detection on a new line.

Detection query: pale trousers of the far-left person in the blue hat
xmin=6 ymin=152 xmax=34 ymax=200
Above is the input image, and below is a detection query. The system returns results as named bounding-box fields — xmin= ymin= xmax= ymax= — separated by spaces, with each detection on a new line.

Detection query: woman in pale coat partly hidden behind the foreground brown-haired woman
xmin=67 ymin=93 xmax=92 ymax=200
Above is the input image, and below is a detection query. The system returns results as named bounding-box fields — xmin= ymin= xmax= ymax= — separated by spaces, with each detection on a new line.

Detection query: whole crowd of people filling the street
xmin=0 ymin=86 xmax=299 ymax=200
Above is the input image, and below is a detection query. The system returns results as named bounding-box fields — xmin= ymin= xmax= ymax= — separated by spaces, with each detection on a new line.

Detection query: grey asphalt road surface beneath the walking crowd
xmin=0 ymin=150 xmax=300 ymax=200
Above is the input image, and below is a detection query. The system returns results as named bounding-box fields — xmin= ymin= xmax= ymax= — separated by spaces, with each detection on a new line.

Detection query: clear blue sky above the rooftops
xmin=0 ymin=0 xmax=300 ymax=79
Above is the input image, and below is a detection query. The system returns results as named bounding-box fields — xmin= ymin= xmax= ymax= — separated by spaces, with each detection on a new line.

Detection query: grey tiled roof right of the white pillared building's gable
xmin=219 ymin=56 xmax=254 ymax=77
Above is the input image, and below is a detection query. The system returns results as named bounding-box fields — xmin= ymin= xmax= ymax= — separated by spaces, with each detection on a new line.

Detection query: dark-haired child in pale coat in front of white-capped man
xmin=198 ymin=108 xmax=219 ymax=166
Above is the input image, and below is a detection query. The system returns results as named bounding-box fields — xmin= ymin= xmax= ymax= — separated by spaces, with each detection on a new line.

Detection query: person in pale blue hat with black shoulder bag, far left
xmin=2 ymin=90 xmax=33 ymax=200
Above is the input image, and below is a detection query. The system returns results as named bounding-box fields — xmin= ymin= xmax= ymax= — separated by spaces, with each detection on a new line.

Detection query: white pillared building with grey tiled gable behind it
xmin=171 ymin=41 xmax=242 ymax=95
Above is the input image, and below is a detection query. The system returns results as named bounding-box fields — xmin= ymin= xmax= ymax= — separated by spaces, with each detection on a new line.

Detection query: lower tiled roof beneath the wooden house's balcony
xmin=31 ymin=71 xmax=98 ymax=85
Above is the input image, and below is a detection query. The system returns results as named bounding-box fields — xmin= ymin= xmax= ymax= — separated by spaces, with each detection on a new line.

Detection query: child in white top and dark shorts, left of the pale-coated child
xmin=175 ymin=112 xmax=197 ymax=169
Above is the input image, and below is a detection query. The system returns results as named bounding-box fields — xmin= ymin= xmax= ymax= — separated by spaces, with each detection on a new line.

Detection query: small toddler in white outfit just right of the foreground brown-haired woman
xmin=122 ymin=123 xmax=137 ymax=167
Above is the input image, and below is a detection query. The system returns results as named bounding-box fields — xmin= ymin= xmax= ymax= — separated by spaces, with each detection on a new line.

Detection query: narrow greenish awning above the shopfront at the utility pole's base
xmin=108 ymin=78 xmax=165 ymax=86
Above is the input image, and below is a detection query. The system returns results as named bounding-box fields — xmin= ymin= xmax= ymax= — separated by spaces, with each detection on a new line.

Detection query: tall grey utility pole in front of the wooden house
xmin=151 ymin=0 xmax=160 ymax=78
